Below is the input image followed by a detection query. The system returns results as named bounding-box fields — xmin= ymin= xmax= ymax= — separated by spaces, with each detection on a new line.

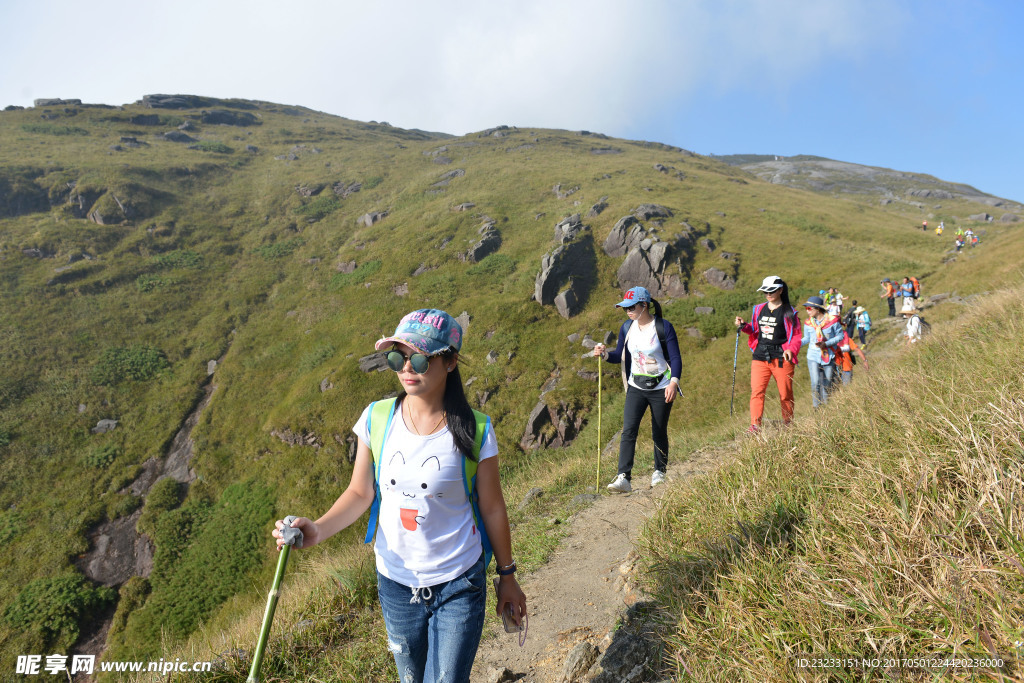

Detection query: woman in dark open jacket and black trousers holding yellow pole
xmin=594 ymin=287 xmax=683 ymax=494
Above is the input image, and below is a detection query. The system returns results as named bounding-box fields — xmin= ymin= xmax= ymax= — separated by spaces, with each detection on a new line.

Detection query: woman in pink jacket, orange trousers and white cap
xmin=736 ymin=275 xmax=801 ymax=432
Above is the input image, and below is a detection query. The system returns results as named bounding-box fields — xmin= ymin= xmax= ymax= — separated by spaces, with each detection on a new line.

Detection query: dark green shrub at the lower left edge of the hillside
xmin=3 ymin=573 xmax=116 ymax=651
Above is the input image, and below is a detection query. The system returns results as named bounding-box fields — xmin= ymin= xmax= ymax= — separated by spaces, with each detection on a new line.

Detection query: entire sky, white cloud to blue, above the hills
xmin=0 ymin=0 xmax=1024 ymax=202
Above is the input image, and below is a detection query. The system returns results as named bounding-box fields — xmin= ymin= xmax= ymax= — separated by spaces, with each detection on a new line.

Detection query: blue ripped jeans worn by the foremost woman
xmin=377 ymin=555 xmax=487 ymax=683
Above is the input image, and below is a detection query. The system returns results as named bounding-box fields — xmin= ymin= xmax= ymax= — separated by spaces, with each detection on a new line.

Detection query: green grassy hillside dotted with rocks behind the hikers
xmin=0 ymin=100 xmax=1019 ymax=679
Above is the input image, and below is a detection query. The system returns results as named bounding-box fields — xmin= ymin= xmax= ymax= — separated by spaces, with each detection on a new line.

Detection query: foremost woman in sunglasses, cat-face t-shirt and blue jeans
xmin=273 ymin=309 xmax=526 ymax=683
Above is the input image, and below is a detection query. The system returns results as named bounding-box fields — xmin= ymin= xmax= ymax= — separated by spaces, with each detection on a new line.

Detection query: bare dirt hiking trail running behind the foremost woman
xmin=472 ymin=446 xmax=734 ymax=683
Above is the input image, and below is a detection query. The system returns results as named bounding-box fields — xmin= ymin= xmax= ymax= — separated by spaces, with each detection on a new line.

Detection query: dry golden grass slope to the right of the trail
xmin=644 ymin=288 xmax=1024 ymax=681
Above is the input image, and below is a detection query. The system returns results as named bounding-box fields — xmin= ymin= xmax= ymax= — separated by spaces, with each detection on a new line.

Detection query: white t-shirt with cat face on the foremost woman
xmin=352 ymin=403 xmax=498 ymax=588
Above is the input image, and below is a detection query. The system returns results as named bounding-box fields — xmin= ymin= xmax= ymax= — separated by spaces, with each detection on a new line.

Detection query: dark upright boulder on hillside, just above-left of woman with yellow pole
xmin=534 ymin=214 xmax=597 ymax=318
